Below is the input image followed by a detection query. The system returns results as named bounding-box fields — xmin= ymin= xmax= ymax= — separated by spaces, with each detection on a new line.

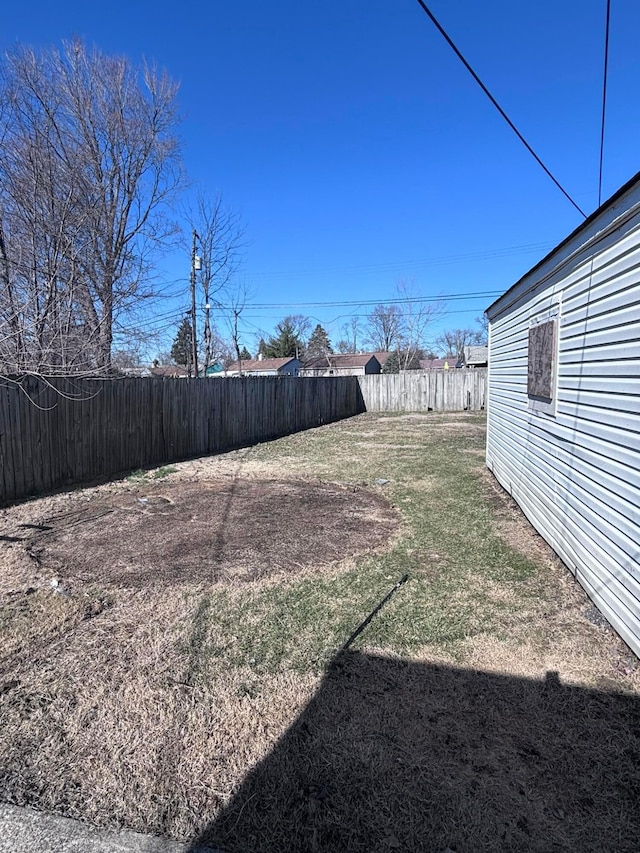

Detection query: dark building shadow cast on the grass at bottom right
xmin=191 ymin=652 xmax=640 ymax=853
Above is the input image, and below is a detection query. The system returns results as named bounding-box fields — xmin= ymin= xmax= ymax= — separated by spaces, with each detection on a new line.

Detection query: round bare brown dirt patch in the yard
xmin=31 ymin=479 xmax=398 ymax=587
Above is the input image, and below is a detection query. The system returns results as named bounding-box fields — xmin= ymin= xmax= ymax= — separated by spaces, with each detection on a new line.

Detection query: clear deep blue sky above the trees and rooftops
xmin=0 ymin=0 xmax=640 ymax=350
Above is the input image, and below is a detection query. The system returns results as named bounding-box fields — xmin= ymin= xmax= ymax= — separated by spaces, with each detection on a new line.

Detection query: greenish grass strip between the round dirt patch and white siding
xmin=186 ymin=415 xmax=552 ymax=673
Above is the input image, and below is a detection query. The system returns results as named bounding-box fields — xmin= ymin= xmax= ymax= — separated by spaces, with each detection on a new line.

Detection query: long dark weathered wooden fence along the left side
xmin=0 ymin=376 xmax=364 ymax=501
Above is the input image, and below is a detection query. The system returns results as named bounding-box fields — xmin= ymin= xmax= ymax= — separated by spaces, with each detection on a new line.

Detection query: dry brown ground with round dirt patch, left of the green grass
xmin=0 ymin=451 xmax=399 ymax=838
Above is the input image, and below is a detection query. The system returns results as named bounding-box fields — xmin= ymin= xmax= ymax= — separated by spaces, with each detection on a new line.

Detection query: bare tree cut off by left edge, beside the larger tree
xmin=0 ymin=52 xmax=83 ymax=372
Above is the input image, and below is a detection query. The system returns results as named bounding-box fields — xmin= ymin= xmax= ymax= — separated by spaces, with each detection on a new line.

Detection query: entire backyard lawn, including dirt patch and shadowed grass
xmin=0 ymin=413 xmax=640 ymax=853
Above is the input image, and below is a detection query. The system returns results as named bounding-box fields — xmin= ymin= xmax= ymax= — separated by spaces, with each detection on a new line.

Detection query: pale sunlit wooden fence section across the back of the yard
xmin=358 ymin=368 xmax=487 ymax=412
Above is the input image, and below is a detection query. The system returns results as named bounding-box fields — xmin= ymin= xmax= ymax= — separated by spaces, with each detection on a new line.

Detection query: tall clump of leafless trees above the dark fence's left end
xmin=0 ymin=40 xmax=182 ymax=373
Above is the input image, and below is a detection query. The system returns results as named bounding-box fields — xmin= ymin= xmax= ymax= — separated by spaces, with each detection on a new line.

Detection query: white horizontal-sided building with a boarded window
xmin=487 ymin=173 xmax=640 ymax=655
